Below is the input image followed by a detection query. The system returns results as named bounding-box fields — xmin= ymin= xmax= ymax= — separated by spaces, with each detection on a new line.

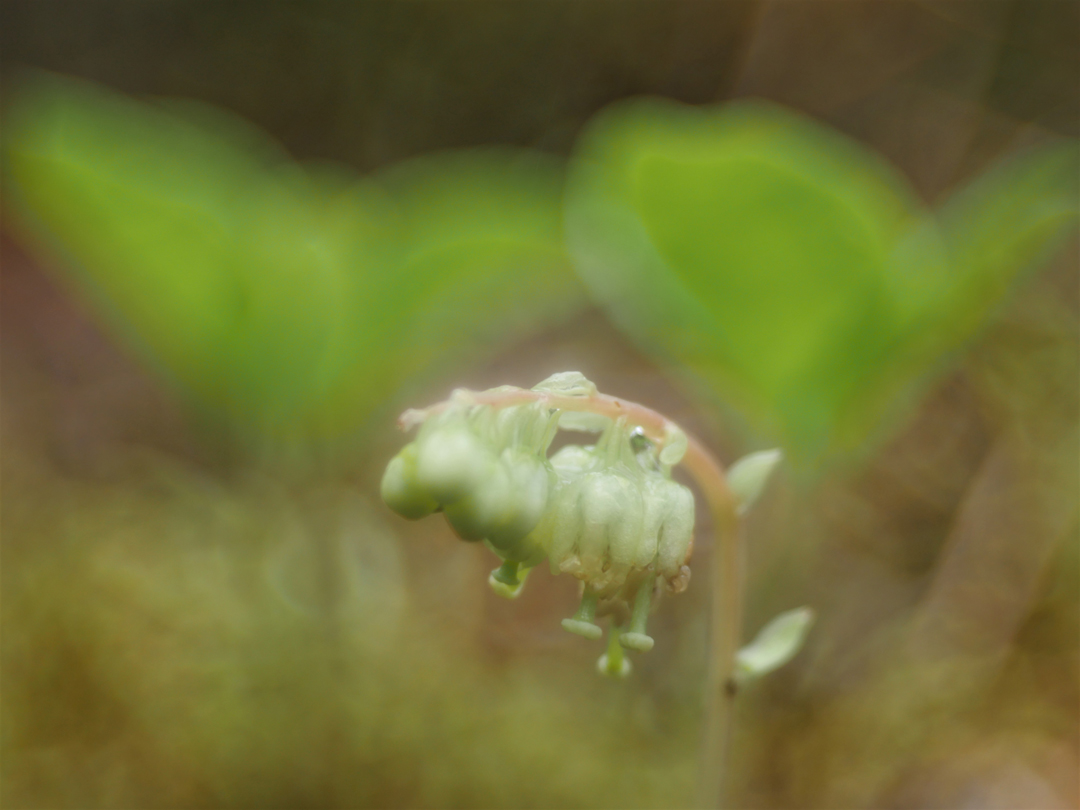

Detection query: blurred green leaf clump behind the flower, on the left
xmin=4 ymin=77 xmax=581 ymax=457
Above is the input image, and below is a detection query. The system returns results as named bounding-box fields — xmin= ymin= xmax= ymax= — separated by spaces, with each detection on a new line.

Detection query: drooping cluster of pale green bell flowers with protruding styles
xmin=382 ymin=372 xmax=694 ymax=675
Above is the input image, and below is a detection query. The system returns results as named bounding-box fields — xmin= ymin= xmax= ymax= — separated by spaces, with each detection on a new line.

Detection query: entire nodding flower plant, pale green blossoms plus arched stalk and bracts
xmin=382 ymin=372 xmax=808 ymax=807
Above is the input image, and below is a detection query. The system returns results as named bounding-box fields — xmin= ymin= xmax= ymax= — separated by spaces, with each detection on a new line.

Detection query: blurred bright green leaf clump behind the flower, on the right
xmin=567 ymin=99 xmax=1077 ymax=457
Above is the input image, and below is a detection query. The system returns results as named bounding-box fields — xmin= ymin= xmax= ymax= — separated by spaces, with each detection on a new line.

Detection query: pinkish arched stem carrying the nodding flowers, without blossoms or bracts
xmin=397 ymin=389 xmax=743 ymax=808
